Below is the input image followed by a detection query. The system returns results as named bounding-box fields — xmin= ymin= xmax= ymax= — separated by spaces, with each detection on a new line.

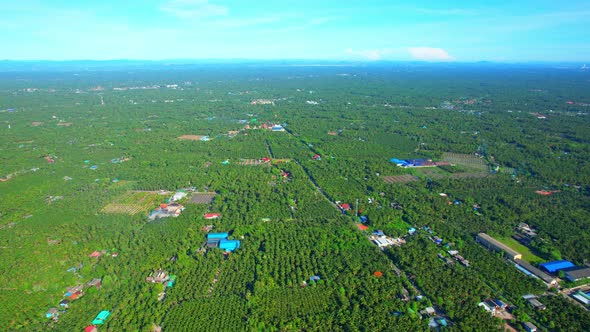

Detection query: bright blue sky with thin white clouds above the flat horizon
xmin=0 ymin=0 xmax=590 ymax=62
